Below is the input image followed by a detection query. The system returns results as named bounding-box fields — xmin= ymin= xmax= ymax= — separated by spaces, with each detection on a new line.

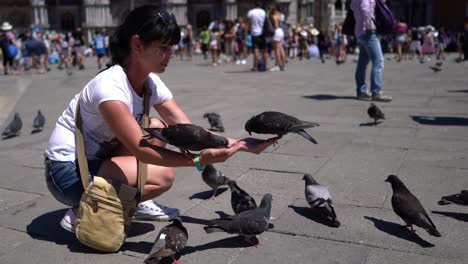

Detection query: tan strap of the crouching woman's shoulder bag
xmin=75 ymin=82 xmax=151 ymax=200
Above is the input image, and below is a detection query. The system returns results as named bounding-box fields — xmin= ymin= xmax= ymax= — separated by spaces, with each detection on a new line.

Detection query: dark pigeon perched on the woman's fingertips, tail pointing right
xmin=245 ymin=111 xmax=319 ymax=144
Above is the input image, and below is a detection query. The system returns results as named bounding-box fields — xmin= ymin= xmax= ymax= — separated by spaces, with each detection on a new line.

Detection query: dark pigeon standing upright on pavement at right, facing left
xmin=385 ymin=175 xmax=441 ymax=237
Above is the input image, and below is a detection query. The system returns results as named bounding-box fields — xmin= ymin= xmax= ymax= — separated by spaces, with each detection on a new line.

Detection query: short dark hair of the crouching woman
xmin=109 ymin=5 xmax=180 ymax=64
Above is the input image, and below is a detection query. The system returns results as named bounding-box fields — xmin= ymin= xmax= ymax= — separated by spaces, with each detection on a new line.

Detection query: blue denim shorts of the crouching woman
xmin=44 ymin=158 xmax=102 ymax=208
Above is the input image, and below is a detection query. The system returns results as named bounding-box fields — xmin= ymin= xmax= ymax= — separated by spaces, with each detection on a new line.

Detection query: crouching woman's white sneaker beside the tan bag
xmin=133 ymin=200 xmax=180 ymax=221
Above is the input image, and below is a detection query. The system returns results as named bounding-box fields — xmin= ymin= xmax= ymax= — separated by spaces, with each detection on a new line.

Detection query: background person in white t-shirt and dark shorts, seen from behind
xmin=247 ymin=1 xmax=268 ymax=71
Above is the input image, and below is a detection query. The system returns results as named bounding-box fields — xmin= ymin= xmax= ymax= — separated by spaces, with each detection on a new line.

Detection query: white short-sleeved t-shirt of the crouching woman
xmin=45 ymin=65 xmax=173 ymax=161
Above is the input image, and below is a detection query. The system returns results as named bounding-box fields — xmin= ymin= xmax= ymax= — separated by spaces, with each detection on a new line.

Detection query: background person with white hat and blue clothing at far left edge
xmin=0 ymin=21 xmax=18 ymax=75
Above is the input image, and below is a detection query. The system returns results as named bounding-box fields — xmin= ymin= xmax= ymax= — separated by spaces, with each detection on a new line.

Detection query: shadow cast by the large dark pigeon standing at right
xmin=364 ymin=216 xmax=435 ymax=248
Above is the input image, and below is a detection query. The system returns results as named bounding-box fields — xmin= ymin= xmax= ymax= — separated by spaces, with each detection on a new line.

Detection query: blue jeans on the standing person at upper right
xmin=355 ymin=31 xmax=383 ymax=96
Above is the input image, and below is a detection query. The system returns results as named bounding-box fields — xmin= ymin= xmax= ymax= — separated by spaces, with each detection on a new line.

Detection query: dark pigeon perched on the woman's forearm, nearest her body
xmin=145 ymin=124 xmax=229 ymax=153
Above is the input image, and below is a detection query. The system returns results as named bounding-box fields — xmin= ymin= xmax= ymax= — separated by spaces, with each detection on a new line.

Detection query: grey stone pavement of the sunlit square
xmin=0 ymin=55 xmax=468 ymax=264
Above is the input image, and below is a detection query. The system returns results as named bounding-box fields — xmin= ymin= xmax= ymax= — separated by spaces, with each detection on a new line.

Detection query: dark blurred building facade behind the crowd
xmin=0 ymin=0 xmax=468 ymax=37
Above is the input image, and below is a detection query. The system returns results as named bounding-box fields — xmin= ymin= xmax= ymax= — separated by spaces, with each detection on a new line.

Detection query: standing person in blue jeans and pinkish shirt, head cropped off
xmin=351 ymin=0 xmax=392 ymax=102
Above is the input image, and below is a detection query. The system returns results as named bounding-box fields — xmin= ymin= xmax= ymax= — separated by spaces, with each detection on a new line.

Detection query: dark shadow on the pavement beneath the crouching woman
xmin=26 ymin=209 xmax=155 ymax=254
